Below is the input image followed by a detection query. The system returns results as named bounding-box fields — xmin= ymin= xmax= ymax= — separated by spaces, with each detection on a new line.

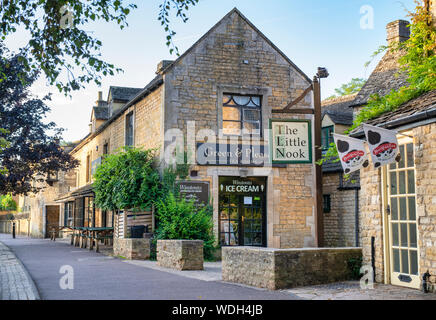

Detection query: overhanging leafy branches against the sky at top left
xmin=0 ymin=0 xmax=198 ymax=94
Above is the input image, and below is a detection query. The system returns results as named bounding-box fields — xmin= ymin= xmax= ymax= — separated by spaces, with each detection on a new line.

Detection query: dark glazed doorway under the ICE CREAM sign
xmin=219 ymin=177 xmax=266 ymax=247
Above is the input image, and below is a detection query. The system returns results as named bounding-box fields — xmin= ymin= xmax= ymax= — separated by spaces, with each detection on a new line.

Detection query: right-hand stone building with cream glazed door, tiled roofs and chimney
xmin=351 ymin=14 xmax=436 ymax=290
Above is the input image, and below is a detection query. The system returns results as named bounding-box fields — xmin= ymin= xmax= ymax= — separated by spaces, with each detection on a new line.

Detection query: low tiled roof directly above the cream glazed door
xmin=351 ymin=90 xmax=436 ymax=136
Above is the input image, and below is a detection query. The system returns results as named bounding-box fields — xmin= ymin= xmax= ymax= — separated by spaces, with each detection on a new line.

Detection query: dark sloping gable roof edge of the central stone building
xmin=163 ymin=8 xmax=312 ymax=83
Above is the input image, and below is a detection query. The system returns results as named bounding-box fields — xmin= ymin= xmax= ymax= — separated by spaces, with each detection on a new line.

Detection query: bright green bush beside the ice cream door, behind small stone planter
xmin=156 ymin=193 xmax=214 ymax=260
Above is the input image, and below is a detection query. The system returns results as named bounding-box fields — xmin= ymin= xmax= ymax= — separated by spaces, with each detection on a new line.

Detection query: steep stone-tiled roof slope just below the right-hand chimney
xmin=352 ymin=50 xmax=408 ymax=107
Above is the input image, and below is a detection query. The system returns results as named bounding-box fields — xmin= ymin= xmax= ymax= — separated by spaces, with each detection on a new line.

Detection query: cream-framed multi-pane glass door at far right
xmin=387 ymin=142 xmax=420 ymax=289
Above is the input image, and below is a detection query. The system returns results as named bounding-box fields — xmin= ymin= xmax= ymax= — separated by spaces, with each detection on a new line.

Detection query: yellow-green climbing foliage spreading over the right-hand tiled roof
xmin=317 ymin=1 xmax=436 ymax=165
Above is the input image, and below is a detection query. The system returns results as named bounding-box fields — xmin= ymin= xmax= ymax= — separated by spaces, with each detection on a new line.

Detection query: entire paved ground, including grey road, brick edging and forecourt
xmin=0 ymin=234 xmax=436 ymax=300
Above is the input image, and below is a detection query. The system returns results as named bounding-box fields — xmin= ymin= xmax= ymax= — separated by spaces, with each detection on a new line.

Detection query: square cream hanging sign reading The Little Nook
xmin=270 ymin=119 xmax=312 ymax=164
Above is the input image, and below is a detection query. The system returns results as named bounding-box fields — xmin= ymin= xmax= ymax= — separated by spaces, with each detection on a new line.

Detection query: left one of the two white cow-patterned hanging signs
xmin=333 ymin=133 xmax=369 ymax=174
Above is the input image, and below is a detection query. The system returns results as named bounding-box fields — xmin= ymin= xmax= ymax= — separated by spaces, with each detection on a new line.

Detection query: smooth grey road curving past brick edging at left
xmin=0 ymin=234 xmax=298 ymax=300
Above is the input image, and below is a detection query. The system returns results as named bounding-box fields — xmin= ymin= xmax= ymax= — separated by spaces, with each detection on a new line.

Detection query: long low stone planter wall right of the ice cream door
xmin=222 ymin=247 xmax=362 ymax=290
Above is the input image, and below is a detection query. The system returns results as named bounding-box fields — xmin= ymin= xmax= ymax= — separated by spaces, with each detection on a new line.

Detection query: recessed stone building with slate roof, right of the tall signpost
xmin=322 ymin=94 xmax=360 ymax=247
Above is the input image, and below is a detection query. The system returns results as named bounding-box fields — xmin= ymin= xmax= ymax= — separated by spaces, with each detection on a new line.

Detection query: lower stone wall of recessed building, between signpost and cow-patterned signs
xmin=323 ymin=173 xmax=356 ymax=247
